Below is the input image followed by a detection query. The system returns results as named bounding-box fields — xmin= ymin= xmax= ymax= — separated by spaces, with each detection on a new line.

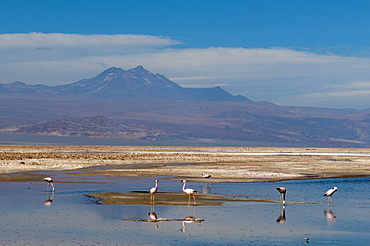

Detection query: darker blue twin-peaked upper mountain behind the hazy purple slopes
xmin=0 ymin=66 xmax=249 ymax=101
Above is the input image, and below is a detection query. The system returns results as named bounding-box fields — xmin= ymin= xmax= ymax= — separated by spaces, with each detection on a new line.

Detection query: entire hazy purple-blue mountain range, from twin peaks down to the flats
xmin=0 ymin=66 xmax=370 ymax=147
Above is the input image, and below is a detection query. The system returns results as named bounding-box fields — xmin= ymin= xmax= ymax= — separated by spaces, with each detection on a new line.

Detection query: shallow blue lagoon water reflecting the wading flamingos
xmin=0 ymin=172 xmax=370 ymax=245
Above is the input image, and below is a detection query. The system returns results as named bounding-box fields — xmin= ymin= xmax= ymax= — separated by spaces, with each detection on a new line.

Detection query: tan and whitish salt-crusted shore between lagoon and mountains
xmin=0 ymin=145 xmax=370 ymax=182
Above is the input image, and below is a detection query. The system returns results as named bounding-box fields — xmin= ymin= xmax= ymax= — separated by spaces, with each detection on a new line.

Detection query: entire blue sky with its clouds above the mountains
xmin=0 ymin=0 xmax=370 ymax=109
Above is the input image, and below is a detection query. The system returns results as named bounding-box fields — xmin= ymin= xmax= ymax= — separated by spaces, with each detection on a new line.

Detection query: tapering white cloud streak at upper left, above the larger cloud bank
xmin=0 ymin=32 xmax=181 ymax=64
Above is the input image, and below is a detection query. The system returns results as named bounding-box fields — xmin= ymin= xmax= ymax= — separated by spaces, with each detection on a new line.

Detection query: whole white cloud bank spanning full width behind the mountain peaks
xmin=0 ymin=33 xmax=370 ymax=108
